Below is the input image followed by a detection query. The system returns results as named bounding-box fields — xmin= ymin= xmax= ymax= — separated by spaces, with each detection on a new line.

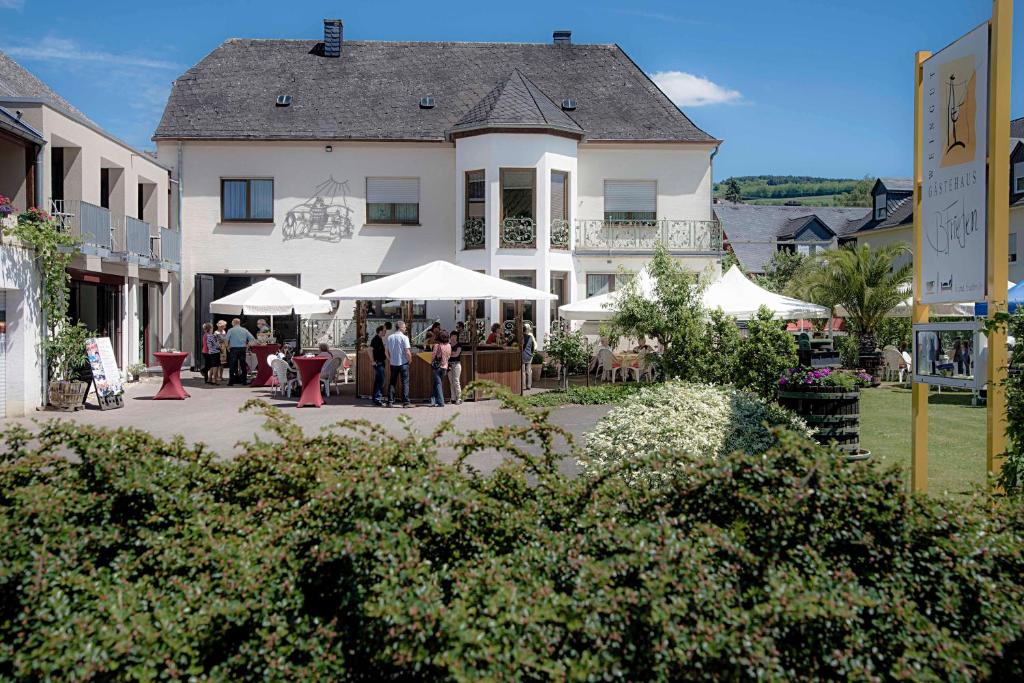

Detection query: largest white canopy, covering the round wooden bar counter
xmin=323 ymin=261 xmax=558 ymax=301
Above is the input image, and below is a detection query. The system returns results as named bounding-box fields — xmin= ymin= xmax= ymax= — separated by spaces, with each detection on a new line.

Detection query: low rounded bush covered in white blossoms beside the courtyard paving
xmin=580 ymin=381 xmax=809 ymax=483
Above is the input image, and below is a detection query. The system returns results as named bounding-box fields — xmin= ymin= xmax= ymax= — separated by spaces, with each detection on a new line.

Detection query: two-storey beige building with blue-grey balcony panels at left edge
xmin=0 ymin=52 xmax=181 ymax=417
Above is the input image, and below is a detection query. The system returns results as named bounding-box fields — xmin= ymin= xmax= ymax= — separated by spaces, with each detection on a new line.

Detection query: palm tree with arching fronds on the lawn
xmin=790 ymin=244 xmax=913 ymax=353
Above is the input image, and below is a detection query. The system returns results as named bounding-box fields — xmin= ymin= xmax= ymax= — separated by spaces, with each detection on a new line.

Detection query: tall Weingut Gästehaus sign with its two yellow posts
xmin=910 ymin=0 xmax=1013 ymax=492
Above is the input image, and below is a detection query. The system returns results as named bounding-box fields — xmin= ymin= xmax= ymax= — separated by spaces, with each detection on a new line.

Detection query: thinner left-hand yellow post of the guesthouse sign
xmin=910 ymin=50 xmax=932 ymax=493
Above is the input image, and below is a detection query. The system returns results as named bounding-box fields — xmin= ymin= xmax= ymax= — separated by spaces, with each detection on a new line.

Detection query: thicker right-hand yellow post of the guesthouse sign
xmin=985 ymin=0 xmax=1014 ymax=483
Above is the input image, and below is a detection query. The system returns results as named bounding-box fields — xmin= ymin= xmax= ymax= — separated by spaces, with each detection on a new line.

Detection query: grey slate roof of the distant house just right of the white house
xmin=715 ymin=203 xmax=869 ymax=272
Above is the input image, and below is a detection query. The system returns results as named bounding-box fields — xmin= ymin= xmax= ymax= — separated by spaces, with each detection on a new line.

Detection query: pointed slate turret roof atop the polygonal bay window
xmin=452 ymin=69 xmax=583 ymax=137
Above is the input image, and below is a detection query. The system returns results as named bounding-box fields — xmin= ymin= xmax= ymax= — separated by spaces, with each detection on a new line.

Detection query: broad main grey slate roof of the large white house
xmin=154 ymin=39 xmax=716 ymax=142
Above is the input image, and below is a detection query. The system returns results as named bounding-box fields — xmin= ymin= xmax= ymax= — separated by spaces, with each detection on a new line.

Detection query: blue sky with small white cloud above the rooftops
xmin=0 ymin=0 xmax=1024 ymax=179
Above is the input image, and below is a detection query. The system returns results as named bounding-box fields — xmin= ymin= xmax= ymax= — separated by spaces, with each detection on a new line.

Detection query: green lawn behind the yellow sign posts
xmin=860 ymin=386 xmax=985 ymax=495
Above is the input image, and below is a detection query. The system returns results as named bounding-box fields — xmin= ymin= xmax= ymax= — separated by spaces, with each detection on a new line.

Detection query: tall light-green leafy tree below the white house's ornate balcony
xmin=611 ymin=244 xmax=706 ymax=380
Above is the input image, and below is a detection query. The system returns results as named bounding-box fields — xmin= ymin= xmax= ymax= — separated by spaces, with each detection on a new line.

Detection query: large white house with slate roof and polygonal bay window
xmin=154 ymin=19 xmax=721 ymax=356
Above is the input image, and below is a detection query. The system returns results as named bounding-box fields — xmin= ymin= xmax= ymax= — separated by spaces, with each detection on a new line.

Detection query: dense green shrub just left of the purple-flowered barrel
xmin=735 ymin=306 xmax=799 ymax=399
